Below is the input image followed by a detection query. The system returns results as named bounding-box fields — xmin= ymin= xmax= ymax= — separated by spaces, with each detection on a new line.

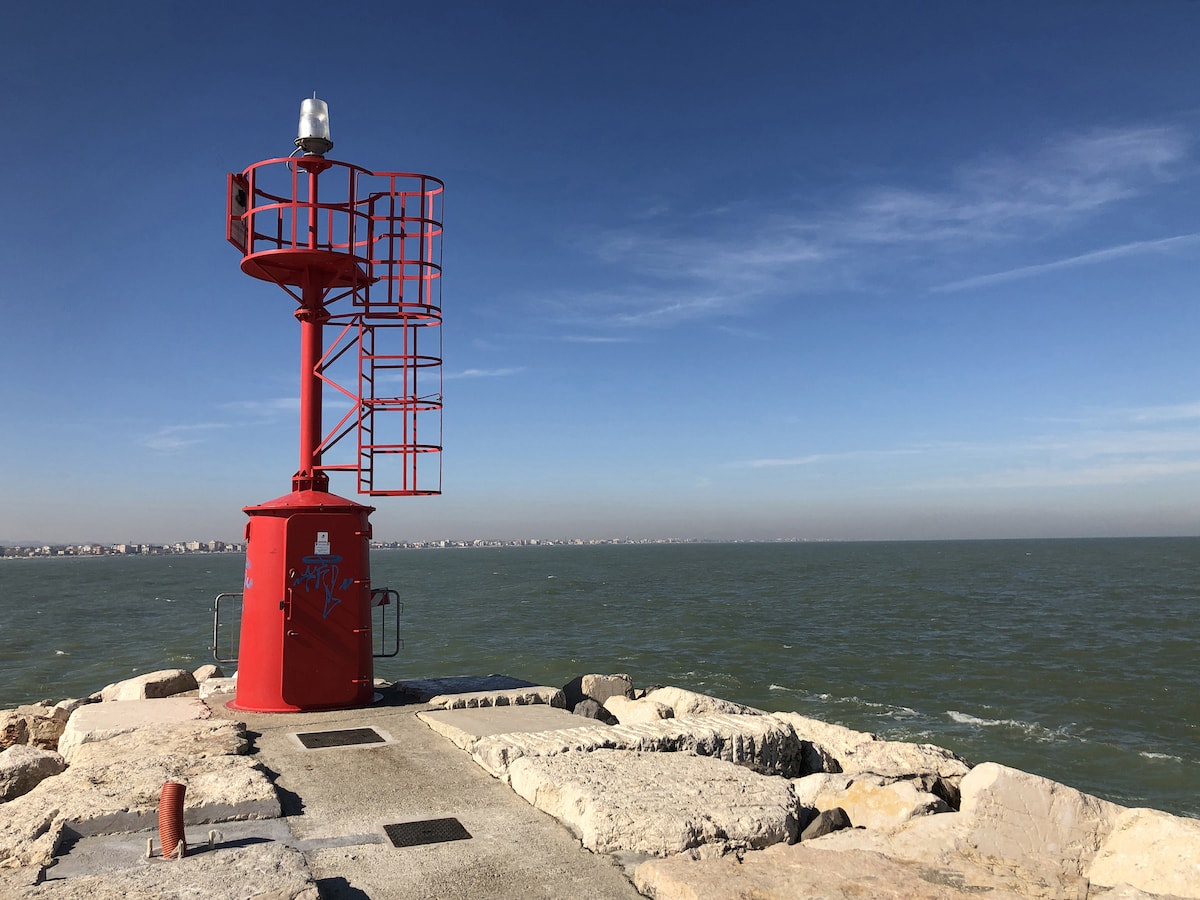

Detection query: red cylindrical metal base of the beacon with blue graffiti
xmin=228 ymin=491 xmax=374 ymax=713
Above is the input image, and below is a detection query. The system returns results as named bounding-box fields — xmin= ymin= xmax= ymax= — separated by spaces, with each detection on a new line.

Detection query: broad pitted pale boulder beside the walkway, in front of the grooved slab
xmin=509 ymin=750 xmax=797 ymax=856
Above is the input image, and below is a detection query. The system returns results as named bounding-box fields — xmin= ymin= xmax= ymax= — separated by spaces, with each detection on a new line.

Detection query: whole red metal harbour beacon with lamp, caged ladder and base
xmin=217 ymin=95 xmax=444 ymax=713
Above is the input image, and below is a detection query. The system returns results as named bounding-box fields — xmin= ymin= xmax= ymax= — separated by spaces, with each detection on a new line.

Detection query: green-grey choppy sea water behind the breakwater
xmin=0 ymin=539 xmax=1200 ymax=816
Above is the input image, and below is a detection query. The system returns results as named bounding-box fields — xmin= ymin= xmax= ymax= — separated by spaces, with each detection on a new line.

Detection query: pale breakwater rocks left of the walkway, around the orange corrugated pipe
xmin=0 ymin=666 xmax=318 ymax=900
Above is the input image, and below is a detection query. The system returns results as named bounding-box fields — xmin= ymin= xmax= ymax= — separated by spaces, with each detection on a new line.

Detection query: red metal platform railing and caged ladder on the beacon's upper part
xmin=226 ymin=157 xmax=445 ymax=496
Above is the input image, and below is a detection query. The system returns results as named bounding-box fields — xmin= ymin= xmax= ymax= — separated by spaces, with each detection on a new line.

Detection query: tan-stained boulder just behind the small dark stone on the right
xmin=792 ymin=774 xmax=950 ymax=830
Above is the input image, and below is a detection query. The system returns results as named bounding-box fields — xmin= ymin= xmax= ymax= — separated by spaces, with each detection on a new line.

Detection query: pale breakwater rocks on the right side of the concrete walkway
xmin=419 ymin=674 xmax=1200 ymax=900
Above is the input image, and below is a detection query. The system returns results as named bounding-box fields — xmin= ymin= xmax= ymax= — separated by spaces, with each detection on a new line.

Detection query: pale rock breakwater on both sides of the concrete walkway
xmin=0 ymin=667 xmax=1200 ymax=900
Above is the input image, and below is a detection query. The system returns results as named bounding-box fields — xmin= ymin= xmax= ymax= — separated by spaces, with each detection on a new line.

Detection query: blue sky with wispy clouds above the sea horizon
xmin=0 ymin=0 xmax=1200 ymax=541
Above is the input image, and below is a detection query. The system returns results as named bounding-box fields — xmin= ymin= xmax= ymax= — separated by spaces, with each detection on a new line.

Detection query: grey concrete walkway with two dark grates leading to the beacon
xmin=214 ymin=685 xmax=641 ymax=900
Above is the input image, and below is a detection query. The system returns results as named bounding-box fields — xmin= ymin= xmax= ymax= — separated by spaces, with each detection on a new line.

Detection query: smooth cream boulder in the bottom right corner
xmin=1087 ymin=809 xmax=1200 ymax=900
